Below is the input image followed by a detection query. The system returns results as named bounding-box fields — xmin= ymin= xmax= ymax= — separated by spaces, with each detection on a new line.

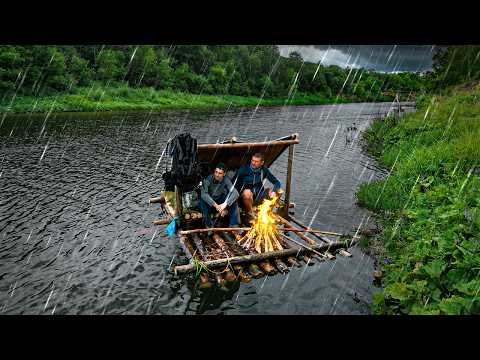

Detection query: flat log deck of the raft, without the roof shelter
xmin=150 ymin=198 xmax=357 ymax=288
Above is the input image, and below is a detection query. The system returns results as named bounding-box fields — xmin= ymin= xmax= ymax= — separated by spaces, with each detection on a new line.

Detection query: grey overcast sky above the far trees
xmin=279 ymin=45 xmax=434 ymax=72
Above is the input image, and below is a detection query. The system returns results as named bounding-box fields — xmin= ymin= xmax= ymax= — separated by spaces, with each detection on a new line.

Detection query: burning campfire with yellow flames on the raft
xmin=238 ymin=194 xmax=283 ymax=253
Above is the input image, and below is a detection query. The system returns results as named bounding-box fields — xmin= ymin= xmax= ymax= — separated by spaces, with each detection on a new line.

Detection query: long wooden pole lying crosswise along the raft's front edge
xmin=174 ymin=242 xmax=345 ymax=275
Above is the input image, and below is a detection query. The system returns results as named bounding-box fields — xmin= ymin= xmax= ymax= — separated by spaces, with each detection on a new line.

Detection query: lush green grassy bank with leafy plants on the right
xmin=357 ymin=87 xmax=480 ymax=314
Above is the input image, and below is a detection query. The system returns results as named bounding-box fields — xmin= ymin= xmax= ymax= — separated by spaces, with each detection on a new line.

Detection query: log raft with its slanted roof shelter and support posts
xmin=150 ymin=134 xmax=357 ymax=285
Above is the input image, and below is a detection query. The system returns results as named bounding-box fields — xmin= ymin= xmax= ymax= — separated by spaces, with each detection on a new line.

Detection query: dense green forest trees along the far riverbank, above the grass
xmin=0 ymin=45 xmax=425 ymax=101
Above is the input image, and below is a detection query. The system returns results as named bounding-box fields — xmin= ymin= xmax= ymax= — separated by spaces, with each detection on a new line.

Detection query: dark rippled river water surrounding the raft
xmin=0 ymin=103 xmax=413 ymax=314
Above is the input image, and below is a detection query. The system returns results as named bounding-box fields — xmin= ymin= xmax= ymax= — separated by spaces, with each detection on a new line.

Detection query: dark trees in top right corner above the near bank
xmin=428 ymin=45 xmax=480 ymax=90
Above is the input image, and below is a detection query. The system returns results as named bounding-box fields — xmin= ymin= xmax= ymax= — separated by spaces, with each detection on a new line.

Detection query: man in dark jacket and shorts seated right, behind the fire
xmin=235 ymin=153 xmax=282 ymax=217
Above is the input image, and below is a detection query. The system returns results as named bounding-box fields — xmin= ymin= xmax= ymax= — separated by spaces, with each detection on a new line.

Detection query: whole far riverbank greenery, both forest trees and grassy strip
xmin=0 ymin=45 xmax=428 ymax=113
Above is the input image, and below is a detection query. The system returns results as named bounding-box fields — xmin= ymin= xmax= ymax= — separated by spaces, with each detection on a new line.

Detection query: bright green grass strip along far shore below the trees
xmin=0 ymin=86 xmax=389 ymax=113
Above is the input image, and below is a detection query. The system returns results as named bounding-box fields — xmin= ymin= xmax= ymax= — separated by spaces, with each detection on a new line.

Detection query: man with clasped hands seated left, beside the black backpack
xmin=199 ymin=163 xmax=238 ymax=235
